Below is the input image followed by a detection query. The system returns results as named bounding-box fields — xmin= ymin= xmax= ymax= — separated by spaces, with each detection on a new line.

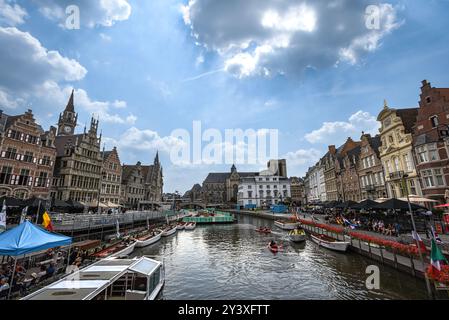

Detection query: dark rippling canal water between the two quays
xmin=134 ymin=216 xmax=426 ymax=300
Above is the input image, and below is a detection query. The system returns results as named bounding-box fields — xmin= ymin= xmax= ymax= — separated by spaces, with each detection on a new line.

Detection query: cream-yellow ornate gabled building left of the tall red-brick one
xmin=377 ymin=101 xmax=422 ymax=198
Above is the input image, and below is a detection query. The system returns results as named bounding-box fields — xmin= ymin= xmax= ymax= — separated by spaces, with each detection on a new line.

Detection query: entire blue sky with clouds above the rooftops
xmin=0 ymin=0 xmax=449 ymax=192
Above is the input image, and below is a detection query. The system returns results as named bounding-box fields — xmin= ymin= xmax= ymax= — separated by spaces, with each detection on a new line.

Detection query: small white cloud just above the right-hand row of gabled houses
xmin=305 ymin=110 xmax=380 ymax=144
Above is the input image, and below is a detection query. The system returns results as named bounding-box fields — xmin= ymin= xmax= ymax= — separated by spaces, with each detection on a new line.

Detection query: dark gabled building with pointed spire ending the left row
xmin=122 ymin=153 xmax=164 ymax=209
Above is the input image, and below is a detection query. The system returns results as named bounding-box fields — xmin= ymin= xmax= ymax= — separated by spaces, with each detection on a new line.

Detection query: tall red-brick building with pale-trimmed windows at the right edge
xmin=413 ymin=80 xmax=449 ymax=203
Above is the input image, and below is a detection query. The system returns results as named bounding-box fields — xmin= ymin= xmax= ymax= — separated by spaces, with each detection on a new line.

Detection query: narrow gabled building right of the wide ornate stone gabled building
xmin=100 ymin=147 xmax=122 ymax=205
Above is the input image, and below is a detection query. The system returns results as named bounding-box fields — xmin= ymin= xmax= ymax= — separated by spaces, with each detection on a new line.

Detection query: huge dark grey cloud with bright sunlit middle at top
xmin=181 ymin=0 xmax=401 ymax=78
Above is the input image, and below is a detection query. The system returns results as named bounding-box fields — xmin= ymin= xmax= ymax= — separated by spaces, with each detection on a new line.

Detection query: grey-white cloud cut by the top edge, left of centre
xmin=33 ymin=0 xmax=132 ymax=28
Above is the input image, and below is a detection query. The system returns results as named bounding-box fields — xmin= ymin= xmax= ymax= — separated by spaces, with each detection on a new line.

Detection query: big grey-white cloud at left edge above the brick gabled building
xmin=0 ymin=27 xmax=137 ymax=125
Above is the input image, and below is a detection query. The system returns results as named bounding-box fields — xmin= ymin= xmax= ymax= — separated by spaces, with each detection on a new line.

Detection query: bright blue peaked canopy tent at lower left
xmin=0 ymin=221 xmax=72 ymax=257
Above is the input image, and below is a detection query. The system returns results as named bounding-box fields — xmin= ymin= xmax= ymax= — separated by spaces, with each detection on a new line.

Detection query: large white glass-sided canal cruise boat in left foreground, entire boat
xmin=22 ymin=257 xmax=165 ymax=300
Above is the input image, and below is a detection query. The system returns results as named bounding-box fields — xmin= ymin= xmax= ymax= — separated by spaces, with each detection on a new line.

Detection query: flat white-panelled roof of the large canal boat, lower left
xmin=23 ymin=257 xmax=161 ymax=300
